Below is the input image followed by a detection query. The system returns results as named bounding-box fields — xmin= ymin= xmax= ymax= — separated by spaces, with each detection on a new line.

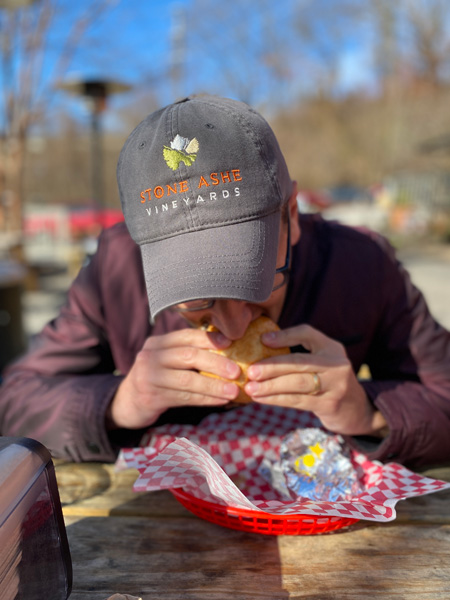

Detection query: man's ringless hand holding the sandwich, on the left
xmin=106 ymin=329 xmax=240 ymax=429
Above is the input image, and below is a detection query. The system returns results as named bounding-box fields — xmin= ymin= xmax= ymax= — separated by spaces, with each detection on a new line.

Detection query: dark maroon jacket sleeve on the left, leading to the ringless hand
xmin=0 ymin=232 xmax=138 ymax=461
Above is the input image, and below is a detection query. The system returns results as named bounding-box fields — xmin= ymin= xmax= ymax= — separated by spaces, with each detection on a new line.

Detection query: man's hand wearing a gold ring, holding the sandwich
xmin=245 ymin=325 xmax=386 ymax=435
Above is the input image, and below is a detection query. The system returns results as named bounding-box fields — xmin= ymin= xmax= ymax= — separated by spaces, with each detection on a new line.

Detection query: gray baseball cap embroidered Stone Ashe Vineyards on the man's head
xmin=117 ymin=95 xmax=292 ymax=317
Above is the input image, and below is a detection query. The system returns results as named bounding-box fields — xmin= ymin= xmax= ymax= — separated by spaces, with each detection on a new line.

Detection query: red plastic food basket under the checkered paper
xmin=170 ymin=488 xmax=358 ymax=535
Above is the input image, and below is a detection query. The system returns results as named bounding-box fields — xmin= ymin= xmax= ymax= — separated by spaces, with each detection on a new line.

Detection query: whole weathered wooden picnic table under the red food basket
xmin=56 ymin=463 xmax=450 ymax=600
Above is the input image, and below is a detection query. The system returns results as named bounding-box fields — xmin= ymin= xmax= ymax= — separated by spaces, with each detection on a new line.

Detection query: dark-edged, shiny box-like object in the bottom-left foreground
xmin=0 ymin=437 xmax=72 ymax=600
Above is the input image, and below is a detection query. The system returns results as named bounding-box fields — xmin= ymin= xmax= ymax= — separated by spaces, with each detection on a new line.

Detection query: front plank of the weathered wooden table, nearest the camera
xmin=66 ymin=517 xmax=450 ymax=600
